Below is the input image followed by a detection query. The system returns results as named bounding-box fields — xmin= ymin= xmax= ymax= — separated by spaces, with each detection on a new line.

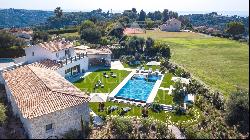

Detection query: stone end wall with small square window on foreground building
xmin=30 ymin=103 xmax=89 ymax=139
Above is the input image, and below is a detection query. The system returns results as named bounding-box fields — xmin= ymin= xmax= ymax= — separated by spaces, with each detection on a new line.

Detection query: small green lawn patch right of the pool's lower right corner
xmin=154 ymin=89 xmax=174 ymax=105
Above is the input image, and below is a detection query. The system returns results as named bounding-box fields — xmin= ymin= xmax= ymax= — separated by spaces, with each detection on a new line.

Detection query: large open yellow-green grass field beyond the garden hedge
xmin=133 ymin=31 xmax=249 ymax=95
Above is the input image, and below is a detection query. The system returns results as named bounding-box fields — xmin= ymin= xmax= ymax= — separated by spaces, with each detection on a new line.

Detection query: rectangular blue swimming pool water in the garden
xmin=114 ymin=75 xmax=158 ymax=102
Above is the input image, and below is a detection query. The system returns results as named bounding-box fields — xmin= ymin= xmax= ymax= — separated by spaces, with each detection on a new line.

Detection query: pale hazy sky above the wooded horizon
xmin=0 ymin=0 xmax=249 ymax=12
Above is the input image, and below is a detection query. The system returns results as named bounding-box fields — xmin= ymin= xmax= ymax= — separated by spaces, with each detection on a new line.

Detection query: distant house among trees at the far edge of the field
xmin=160 ymin=18 xmax=181 ymax=32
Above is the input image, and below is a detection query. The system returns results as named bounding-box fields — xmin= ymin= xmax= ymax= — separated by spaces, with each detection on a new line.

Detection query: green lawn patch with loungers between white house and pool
xmin=73 ymin=69 xmax=130 ymax=93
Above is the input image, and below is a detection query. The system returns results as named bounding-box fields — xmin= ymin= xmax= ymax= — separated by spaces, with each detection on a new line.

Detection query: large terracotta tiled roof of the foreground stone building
xmin=3 ymin=65 xmax=89 ymax=119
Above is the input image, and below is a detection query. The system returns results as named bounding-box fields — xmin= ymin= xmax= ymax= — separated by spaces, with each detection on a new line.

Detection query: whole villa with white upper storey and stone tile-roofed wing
xmin=0 ymin=39 xmax=111 ymax=139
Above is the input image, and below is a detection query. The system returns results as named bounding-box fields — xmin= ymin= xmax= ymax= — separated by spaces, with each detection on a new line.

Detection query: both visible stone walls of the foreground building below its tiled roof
xmin=5 ymin=85 xmax=90 ymax=139
